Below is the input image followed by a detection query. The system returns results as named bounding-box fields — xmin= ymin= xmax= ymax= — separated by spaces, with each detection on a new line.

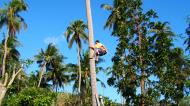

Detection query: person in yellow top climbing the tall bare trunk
xmin=90 ymin=40 xmax=107 ymax=61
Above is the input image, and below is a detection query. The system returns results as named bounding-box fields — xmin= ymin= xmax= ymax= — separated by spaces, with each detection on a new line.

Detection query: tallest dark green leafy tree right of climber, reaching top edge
xmin=103 ymin=0 xmax=160 ymax=105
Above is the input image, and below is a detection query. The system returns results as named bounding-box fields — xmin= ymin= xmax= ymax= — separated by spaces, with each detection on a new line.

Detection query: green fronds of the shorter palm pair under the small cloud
xmin=35 ymin=44 xmax=69 ymax=88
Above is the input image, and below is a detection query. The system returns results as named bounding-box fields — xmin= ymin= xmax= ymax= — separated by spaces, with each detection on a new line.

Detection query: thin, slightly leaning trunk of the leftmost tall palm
xmin=2 ymin=29 xmax=9 ymax=77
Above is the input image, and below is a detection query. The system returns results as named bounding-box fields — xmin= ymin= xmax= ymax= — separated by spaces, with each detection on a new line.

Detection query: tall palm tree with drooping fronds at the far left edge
xmin=0 ymin=0 xmax=27 ymax=76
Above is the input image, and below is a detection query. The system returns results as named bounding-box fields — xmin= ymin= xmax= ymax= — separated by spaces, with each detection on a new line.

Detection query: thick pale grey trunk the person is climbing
xmin=86 ymin=0 xmax=99 ymax=106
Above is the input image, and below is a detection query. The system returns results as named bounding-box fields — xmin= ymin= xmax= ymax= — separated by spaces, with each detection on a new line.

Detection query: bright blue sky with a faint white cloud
xmin=0 ymin=0 xmax=190 ymax=102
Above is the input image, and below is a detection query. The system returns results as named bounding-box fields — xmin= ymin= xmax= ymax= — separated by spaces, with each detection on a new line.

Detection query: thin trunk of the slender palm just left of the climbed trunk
xmin=77 ymin=44 xmax=81 ymax=93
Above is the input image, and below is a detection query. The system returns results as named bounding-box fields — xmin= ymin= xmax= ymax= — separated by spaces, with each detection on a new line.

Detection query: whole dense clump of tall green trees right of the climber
xmin=102 ymin=0 xmax=190 ymax=105
